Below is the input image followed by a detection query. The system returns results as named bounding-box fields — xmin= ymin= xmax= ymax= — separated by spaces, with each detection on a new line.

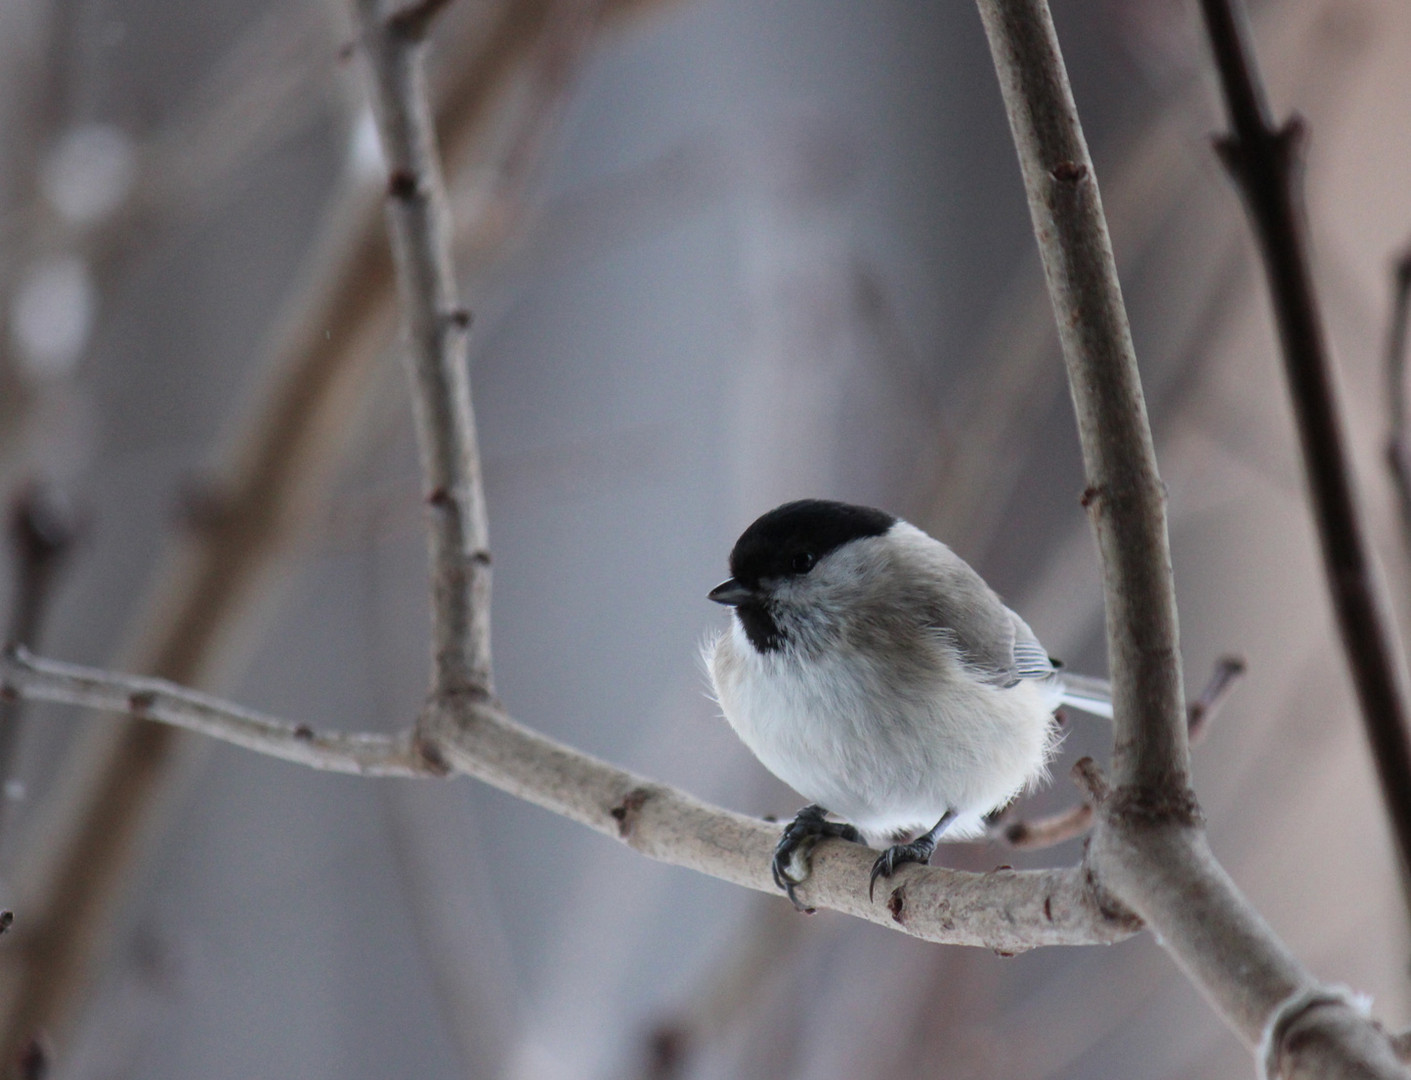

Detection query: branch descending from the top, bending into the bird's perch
xmin=330 ymin=0 xmax=1132 ymax=952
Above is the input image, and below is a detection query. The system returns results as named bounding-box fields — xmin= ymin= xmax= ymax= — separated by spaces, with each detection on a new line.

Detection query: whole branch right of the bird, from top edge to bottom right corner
xmin=979 ymin=0 xmax=1405 ymax=1077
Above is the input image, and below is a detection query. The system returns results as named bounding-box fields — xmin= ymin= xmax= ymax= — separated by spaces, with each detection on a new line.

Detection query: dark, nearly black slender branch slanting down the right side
xmin=1201 ymin=0 xmax=1411 ymax=892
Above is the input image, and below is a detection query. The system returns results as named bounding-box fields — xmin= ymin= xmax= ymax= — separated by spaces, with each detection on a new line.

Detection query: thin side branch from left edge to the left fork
xmin=0 ymin=645 xmax=428 ymax=776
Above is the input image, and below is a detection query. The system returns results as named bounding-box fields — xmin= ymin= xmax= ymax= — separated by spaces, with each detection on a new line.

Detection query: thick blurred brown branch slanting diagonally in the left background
xmin=0 ymin=0 xmax=668 ymax=1060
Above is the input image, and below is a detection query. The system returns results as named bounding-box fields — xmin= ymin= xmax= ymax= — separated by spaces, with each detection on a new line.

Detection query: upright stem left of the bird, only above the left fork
xmin=356 ymin=0 xmax=492 ymax=696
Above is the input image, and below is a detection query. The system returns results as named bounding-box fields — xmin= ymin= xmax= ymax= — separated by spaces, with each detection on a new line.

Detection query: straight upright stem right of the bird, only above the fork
xmin=979 ymin=0 xmax=1188 ymax=789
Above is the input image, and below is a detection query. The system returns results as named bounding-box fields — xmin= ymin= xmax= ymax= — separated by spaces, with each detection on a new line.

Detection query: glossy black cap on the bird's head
xmin=729 ymin=498 xmax=896 ymax=587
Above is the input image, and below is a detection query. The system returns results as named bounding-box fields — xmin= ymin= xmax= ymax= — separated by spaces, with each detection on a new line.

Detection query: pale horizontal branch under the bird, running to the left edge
xmin=0 ymin=648 xmax=1140 ymax=953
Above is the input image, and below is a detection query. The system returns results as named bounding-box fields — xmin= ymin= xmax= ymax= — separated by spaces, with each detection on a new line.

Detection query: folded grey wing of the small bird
xmin=927 ymin=563 xmax=1054 ymax=688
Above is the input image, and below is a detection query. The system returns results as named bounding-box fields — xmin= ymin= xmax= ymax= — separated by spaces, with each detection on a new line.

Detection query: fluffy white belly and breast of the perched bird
xmin=707 ymin=620 xmax=1058 ymax=843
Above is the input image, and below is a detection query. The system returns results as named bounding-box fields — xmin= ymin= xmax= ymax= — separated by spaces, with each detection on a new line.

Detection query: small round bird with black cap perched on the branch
xmin=706 ymin=498 xmax=1112 ymax=906
